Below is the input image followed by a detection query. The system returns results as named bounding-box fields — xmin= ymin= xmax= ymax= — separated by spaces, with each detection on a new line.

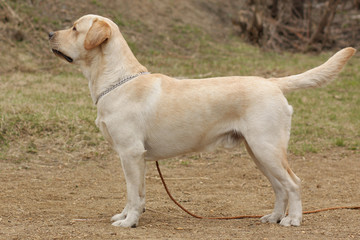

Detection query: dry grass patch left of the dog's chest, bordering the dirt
xmin=0 ymin=73 xmax=103 ymax=163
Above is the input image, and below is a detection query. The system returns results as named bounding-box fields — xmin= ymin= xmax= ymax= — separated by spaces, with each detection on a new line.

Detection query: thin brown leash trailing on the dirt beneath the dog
xmin=155 ymin=161 xmax=360 ymax=220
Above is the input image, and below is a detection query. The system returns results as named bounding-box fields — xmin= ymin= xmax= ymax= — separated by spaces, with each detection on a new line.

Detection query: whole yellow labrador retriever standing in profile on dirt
xmin=49 ymin=15 xmax=355 ymax=227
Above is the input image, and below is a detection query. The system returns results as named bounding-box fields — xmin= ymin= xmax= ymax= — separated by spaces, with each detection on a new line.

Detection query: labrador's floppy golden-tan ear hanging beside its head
xmin=84 ymin=20 xmax=111 ymax=50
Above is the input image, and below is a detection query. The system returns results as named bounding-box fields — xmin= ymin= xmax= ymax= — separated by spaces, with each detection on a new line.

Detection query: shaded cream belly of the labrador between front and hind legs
xmin=144 ymin=116 xmax=243 ymax=160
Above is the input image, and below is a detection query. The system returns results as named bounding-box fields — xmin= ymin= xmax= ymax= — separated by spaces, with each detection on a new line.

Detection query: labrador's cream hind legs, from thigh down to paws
xmin=242 ymin=98 xmax=302 ymax=226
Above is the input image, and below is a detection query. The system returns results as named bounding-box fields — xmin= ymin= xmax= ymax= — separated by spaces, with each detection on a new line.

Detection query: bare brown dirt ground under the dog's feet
xmin=0 ymin=148 xmax=360 ymax=239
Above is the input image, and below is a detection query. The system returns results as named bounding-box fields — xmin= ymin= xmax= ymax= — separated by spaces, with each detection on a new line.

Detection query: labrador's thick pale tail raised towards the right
xmin=269 ymin=47 xmax=356 ymax=93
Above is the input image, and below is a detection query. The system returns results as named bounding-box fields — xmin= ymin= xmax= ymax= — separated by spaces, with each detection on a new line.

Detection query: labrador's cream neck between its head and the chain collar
xmin=80 ymin=32 xmax=147 ymax=104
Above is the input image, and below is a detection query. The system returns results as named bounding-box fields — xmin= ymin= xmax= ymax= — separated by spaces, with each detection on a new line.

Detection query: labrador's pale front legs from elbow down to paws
xmin=111 ymin=144 xmax=146 ymax=227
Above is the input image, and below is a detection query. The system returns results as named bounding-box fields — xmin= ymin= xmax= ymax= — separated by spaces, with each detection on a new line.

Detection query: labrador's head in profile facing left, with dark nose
xmin=49 ymin=15 xmax=112 ymax=63
